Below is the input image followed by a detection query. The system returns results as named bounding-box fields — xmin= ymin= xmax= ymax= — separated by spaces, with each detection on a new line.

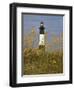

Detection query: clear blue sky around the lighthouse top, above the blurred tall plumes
xmin=22 ymin=14 xmax=63 ymax=46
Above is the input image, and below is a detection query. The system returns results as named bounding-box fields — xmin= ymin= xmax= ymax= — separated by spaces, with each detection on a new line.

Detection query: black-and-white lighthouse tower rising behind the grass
xmin=39 ymin=22 xmax=45 ymax=50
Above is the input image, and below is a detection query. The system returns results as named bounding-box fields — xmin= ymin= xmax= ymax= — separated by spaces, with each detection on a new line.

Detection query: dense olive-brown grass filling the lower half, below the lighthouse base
xmin=24 ymin=48 xmax=63 ymax=75
